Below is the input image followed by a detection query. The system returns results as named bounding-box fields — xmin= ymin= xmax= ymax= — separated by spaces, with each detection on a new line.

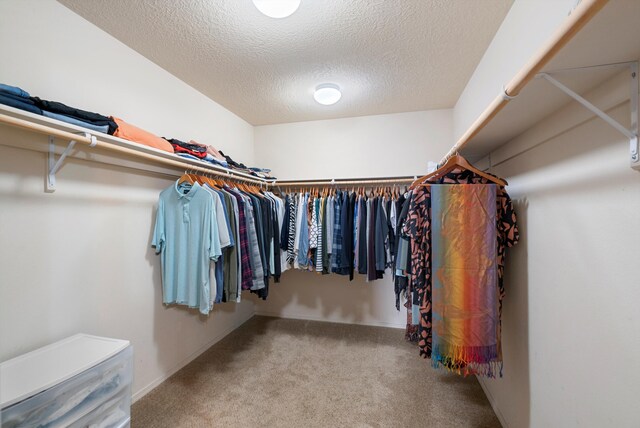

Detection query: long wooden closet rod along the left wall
xmin=0 ymin=113 xmax=271 ymax=184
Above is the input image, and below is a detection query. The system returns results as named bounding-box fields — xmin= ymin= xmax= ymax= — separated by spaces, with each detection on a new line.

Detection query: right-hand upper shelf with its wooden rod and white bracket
xmin=452 ymin=0 xmax=640 ymax=168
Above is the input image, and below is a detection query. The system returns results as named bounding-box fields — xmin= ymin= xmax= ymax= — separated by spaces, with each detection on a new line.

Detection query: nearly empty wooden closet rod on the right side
xmin=440 ymin=0 xmax=608 ymax=164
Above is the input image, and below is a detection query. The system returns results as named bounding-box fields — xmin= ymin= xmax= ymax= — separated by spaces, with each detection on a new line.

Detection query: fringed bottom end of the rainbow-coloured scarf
xmin=431 ymin=343 xmax=503 ymax=378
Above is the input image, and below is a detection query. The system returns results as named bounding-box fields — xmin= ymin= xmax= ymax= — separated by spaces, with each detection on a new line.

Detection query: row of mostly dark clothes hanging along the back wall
xmin=279 ymin=189 xmax=398 ymax=281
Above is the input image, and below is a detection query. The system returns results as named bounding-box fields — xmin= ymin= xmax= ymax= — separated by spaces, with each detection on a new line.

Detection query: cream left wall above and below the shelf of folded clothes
xmin=0 ymin=0 xmax=254 ymax=402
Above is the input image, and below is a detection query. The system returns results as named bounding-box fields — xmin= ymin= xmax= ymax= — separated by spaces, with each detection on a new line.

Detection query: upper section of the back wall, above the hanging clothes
xmin=255 ymin=110 xmax=452 ymax=180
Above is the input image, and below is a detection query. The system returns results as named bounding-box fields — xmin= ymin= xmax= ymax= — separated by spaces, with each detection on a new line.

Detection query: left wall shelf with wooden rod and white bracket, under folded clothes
xmin=0 ymin=104 xmax=274 ymax=191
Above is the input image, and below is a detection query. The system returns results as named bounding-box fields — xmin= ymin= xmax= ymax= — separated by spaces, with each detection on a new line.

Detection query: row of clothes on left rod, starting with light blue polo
xmin=152 ymin=180 xmax=289 ymax=314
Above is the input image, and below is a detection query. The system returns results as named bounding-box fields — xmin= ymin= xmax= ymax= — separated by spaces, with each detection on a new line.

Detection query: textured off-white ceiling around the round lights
xmin=59 ymin=0 xmax=512 ymax=125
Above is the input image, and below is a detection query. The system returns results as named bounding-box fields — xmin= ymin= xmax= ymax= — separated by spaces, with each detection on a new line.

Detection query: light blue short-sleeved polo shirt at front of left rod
xmin=151 ymin=181 xmax=222 ymax=314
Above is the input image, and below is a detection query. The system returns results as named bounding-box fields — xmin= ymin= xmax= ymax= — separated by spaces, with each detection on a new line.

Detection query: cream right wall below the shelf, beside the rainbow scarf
xmin=483 ymin=73 xmax=640 ymax=428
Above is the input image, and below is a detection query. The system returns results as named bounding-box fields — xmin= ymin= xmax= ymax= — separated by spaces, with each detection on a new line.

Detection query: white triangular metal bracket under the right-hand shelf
xmin=538 ymin=62 xmax=640 ymax=170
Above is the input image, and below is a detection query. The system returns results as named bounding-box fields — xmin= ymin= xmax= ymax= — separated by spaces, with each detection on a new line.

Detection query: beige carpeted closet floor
xmin=132 ymin=316 xmax=500 ymax=428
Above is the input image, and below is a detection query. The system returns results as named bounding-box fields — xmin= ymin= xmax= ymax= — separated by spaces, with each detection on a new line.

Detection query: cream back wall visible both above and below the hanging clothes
xmin=255 ymin=110 xmax=452 ymax=327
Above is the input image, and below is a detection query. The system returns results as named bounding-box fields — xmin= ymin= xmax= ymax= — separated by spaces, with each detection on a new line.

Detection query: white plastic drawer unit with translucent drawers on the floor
xmin=0 ymin=334 xmax=133 ymax=428
